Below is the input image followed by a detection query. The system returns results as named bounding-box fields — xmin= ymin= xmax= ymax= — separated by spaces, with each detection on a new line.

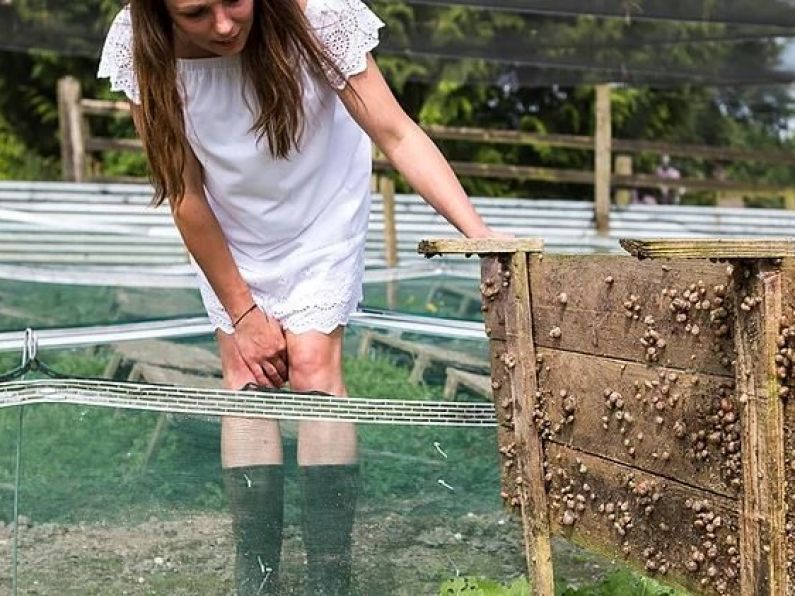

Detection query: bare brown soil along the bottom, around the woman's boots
xmin=0 ymin=506 xmax=607 ymax=596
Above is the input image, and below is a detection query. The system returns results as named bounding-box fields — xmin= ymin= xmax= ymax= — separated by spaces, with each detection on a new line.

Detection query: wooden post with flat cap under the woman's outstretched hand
xmin=419 ymin=239 xmax=555 ymax=596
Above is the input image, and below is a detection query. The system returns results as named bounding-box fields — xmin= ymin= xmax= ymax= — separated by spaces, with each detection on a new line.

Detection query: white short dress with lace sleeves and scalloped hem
xmin=98 ymin=0 xmax=384 ymax=333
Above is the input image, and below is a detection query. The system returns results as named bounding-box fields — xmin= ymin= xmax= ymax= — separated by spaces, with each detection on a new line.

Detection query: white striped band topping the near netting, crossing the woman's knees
xmin=0 ymin=379 xmax=496 ymax=427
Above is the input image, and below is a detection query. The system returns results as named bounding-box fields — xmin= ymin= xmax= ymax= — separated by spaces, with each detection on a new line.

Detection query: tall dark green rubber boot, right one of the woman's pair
xmin=300 ymin=464 xmax=359 ymax=596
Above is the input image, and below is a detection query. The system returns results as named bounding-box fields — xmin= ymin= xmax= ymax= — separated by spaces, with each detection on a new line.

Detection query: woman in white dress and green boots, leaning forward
xmin=99 ymin=0 xmax=494 ymax=594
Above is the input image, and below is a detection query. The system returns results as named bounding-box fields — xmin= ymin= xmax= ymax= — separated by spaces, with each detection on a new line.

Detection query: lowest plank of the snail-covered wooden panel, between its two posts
xmin=547 ymin=443 xmax=739 ymax=595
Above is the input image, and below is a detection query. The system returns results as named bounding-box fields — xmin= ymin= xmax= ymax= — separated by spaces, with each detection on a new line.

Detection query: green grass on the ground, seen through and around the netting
xmin=0 ymin=282 xmax=696 ymax=596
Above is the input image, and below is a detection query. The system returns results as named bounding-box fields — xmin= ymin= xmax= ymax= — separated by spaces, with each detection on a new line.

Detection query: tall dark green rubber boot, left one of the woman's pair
xmin=223 ymin=465 xmax=284 ymax=596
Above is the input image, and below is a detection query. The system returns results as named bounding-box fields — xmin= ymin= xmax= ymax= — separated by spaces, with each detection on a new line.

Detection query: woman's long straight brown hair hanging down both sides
xmin=130 ymin=0 xmax=342 ymax=205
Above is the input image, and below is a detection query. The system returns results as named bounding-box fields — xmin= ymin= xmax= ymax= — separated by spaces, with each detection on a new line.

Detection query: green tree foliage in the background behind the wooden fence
xmin=0 ymin=0 xmax=795 ymax=196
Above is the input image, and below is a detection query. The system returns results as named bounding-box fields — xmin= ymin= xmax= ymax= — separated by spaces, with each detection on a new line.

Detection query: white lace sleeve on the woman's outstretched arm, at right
xmin=306 ymin=0 xmax=384 ymax=89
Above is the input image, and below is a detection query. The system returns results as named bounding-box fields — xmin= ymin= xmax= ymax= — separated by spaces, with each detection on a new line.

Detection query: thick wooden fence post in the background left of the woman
xmin=58 ymin=76 xmax=86 ymax=182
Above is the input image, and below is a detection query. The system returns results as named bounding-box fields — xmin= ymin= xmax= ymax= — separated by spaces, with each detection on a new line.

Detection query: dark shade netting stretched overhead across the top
xmin=0 ymin=0 xmax=795 ymax=86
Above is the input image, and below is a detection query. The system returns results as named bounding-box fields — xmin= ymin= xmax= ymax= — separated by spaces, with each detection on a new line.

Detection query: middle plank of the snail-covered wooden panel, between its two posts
xmin=538 ymin=349 xmax=742 ymax=497
